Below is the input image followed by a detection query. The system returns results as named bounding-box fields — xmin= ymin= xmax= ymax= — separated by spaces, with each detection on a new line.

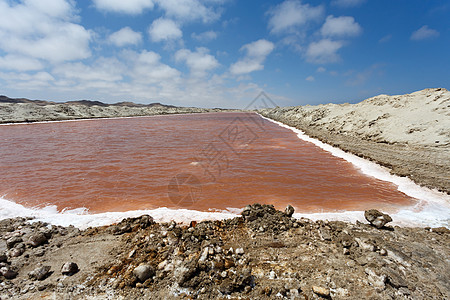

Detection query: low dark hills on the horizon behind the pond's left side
xmin=0 ymin=95 xmax=176 ymax=108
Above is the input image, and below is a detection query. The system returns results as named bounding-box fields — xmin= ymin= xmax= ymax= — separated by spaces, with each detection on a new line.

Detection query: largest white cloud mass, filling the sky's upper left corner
xmin=0 ymin=0 xmax=91 ymax=63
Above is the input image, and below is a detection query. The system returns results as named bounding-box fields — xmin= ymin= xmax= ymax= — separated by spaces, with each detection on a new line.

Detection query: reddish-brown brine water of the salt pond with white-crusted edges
xmin=0 ymin=113 xmax=416 ymax=212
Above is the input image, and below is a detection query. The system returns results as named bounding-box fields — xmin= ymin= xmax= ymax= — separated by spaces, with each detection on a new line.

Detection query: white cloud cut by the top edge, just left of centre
xmin=157 ymin=0 xmax=223 ymax=23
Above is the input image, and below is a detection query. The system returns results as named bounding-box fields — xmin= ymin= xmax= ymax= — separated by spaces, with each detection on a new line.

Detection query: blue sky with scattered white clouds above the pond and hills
xmin=0 ymin=0 xmax=450 ymax=107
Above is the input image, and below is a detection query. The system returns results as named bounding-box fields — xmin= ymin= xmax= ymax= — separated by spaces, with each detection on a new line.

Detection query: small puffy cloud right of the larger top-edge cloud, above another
xmin=320 ymin=16 xmax=362 ymax=37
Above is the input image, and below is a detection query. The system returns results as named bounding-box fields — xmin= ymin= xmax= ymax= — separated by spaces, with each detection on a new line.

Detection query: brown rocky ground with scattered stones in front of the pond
xmin=0 ymin=204 xmax=450 ymax=299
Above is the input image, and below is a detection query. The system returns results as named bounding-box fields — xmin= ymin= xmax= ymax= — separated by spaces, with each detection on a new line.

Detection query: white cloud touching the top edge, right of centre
xmin=268 ymin=0 xmax=324 ymax=33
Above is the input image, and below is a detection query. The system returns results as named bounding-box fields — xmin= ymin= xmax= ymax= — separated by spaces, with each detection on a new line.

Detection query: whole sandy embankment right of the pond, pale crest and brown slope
xmin=259 ymin=89 xmax=450 ymax=193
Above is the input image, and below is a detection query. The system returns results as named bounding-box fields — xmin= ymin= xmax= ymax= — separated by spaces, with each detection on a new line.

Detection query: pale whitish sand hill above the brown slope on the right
xmin=295 ymin=88 xmax=450 ymax=146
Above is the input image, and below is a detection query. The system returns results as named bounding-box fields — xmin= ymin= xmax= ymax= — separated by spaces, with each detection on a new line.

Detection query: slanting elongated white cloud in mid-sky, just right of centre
xmin=230 ymin=39 xmax=275 ymax=75
